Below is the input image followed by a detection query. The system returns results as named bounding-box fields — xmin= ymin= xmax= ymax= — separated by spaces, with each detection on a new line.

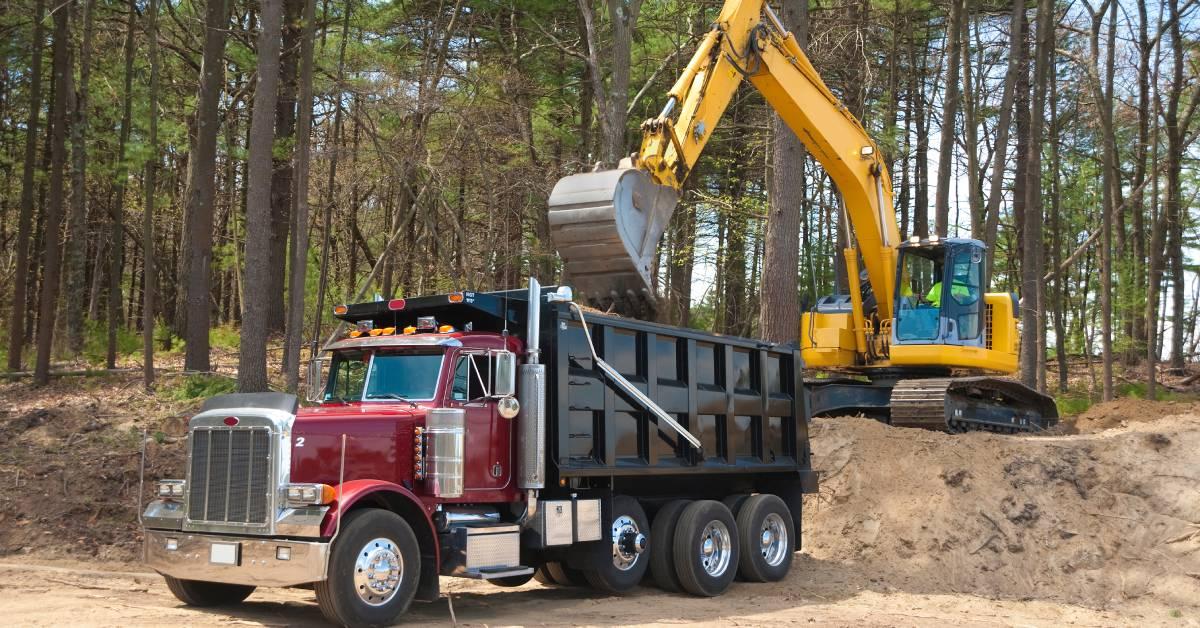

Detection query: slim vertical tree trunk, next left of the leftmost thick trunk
xmin=142 ymin=0 xmax=160 ymax=390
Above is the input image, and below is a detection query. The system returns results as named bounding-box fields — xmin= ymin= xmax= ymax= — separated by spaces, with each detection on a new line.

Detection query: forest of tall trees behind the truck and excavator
xmin=0 ymin=0 xmax=1200 ymax=408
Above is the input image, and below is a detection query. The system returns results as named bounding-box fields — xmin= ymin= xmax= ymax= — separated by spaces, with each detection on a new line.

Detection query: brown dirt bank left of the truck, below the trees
xmin=0 ymin=377 xmax=194 ymax=561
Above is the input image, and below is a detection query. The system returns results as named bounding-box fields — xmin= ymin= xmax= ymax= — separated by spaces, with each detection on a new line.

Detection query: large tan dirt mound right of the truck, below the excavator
xmin=804 ymin=411 xmax=1200 ymax=608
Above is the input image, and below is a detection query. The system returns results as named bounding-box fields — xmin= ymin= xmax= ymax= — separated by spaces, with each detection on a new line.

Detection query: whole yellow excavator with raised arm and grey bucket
xmin=548 ymin=0 xmax=1057 ymax=432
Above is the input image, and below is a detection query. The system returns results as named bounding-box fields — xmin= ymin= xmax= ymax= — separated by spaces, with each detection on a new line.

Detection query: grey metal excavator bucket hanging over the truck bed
xmin=550 ymin=168 xmax=679 ymax=317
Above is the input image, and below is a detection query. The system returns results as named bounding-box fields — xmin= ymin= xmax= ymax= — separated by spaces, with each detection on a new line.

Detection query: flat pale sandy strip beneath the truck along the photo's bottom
xmin=0 ymin=555 xmax=1156 ymax=627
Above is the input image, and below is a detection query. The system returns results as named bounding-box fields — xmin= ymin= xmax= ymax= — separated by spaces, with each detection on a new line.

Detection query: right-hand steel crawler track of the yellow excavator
xmin=890 ymin=377 xmax=1058 ymax=433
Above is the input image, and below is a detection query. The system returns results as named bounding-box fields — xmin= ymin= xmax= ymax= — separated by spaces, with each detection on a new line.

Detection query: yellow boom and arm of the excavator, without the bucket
xmin=634 ymin=0 xmax=900 ymax=328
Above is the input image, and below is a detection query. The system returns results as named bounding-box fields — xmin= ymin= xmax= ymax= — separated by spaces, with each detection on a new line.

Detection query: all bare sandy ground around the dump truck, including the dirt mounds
xmin=0 ymin=377 xmax=1200 ymax=627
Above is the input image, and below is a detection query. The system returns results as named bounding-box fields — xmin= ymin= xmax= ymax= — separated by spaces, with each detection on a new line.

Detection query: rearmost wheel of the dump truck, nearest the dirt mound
xmin=738 ymin=494 xmax=796 ymax=582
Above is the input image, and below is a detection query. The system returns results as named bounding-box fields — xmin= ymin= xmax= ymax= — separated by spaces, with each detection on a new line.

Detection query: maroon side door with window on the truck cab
xmin=446 ymin=354 xmax=512 ymax=491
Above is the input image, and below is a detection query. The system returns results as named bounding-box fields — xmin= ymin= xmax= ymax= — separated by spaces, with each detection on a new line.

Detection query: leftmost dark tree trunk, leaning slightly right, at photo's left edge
xmin=8 ymin=0 xmax=46 ymax=371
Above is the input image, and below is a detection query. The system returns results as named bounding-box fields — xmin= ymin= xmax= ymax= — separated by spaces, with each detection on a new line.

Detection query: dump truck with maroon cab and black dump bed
xmin=142 ymin=281 xmax=816 ymax=626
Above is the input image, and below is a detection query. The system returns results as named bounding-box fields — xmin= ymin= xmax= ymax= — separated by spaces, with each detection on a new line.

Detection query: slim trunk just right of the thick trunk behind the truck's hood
xmin=283 ymin=0 xmax=320 ymax=393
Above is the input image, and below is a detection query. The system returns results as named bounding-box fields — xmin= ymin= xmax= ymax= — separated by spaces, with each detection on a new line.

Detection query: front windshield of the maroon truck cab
xmin=325 ymin=353 xmax=442 ymax=401
